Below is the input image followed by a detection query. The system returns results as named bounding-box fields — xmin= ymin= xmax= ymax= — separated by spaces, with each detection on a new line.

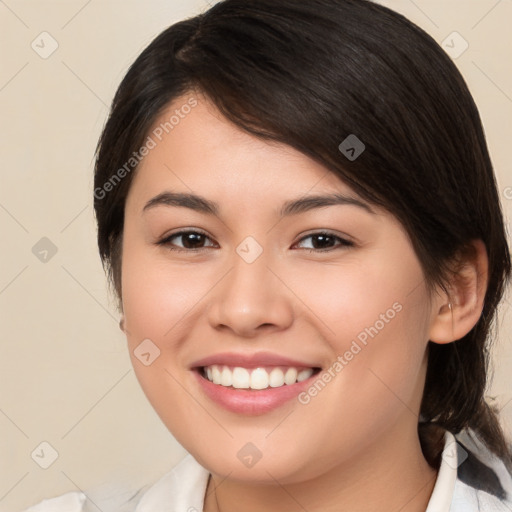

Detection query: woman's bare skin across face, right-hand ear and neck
xmin=122 ymin=93 xmax=487 ymax=512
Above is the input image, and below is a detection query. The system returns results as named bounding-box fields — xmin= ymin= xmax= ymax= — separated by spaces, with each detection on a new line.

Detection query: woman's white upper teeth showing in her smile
xmin=204 ymin=364 xmax=313 ymax=389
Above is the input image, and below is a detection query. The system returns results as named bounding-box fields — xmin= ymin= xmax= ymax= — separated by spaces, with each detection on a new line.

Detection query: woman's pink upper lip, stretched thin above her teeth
xmin=190 ymin=352 xmax=320 ymax=368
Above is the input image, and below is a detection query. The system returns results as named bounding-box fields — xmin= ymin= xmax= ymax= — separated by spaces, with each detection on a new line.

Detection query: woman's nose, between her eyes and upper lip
xmin=208 ymin=247 xmax=293 ymax=338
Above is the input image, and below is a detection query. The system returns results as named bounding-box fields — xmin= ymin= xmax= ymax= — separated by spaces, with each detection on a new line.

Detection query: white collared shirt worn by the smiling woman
xmin=25 ymin=431 xmax=512 ymax=512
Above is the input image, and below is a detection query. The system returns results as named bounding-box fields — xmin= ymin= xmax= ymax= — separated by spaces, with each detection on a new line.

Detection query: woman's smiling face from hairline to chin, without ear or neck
xmin=122 ymin=94 xmax=432 ymax=483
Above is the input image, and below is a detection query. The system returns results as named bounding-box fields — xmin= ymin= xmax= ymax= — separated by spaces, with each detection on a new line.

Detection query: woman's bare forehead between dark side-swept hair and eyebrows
xmin=126 ymin=92 xmax=362 ymax=208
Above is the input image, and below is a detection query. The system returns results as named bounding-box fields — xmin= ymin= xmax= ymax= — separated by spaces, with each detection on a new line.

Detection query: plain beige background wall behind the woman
xmin=0 ymin=0 xmax=512 ymax=511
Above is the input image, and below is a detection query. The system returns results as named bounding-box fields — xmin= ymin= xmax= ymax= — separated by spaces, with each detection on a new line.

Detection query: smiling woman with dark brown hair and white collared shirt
xmin=26 ymin=0 xmax=512 ymax=512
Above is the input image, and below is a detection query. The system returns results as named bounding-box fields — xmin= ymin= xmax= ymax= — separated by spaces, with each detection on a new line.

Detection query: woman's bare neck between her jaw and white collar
xmin=204 ymin=424 xmax=437 ymax=512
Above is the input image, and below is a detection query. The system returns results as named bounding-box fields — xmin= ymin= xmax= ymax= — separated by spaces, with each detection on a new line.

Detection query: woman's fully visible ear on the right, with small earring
xmin=429 ymin=240 xmax=489 ymax=344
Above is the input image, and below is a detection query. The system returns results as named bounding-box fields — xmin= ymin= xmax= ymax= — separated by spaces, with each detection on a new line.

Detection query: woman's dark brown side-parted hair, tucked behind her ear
xmin=94 ymin=0 xmax=512 ymax=468
